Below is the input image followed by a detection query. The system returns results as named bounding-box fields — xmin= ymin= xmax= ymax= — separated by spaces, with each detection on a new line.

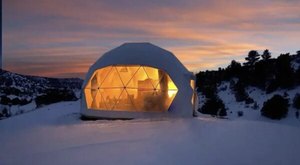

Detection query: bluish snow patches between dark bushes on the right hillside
xmin=210 ymin=82 xmax=300 ymax=123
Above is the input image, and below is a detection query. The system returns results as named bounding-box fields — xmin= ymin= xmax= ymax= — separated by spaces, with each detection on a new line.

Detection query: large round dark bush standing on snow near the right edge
xmin=261 ymin=95 xmax=289 ymax=120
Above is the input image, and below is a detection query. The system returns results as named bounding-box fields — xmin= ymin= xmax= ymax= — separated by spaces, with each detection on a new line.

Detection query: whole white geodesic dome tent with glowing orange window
xmin=81 ymin=43 xmax=194 ymax=118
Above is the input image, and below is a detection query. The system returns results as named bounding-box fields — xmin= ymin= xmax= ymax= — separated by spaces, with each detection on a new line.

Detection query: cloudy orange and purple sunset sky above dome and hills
xmin=2 ymin=0 xmax=300 ymax=78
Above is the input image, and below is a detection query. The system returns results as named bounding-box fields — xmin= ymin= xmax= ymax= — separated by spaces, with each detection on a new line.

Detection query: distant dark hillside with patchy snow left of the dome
xmin=0 ymin=70 xmax=83 ymax=119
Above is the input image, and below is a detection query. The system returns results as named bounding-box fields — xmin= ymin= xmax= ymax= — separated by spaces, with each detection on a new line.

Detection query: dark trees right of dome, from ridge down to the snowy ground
xmin=196 ymin=50 xmax=300 ymax=116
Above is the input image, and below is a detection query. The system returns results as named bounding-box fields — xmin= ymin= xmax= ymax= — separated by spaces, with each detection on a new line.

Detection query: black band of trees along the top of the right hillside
xmin=196 ymin=50 xmax=300 ymax=97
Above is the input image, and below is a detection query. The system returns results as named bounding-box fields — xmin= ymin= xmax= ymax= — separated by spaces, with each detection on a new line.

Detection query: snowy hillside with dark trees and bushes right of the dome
xmin=196 ymin=50 xmax=300 ymax=120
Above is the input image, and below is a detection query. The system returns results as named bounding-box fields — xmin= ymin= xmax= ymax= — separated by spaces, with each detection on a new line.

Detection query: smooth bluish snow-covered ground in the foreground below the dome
xmin=0 ymin=101 xmax=300 ymax=165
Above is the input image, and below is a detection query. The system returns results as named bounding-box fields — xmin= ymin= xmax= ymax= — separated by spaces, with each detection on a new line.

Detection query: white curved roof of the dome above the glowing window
xmin=87 ymin=43 xmax=190 ymax=80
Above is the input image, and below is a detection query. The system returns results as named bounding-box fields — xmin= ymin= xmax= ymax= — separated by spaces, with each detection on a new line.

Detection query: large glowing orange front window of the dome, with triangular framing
xmin=84 ymin=65 xmax=178 ymax=112
